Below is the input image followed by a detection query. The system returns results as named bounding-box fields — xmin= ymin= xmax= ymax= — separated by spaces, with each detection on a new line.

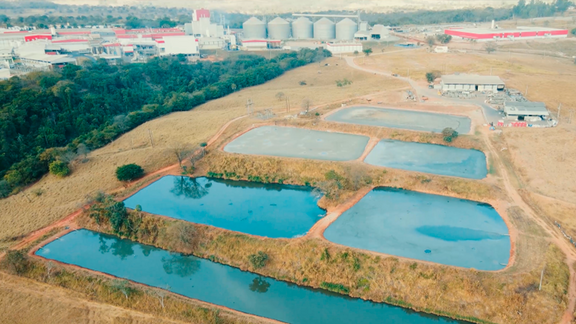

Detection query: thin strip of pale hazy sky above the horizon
xmin=53 ymin=0 xmax=518 ymax=13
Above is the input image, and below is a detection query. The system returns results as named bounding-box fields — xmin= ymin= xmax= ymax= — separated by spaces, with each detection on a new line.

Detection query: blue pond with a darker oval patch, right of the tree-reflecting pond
xmin=324 ymin=188 xmax=510 ymax=270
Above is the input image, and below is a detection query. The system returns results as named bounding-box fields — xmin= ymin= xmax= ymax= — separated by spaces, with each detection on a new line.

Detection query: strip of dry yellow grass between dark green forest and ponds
xmin=0 ymin=58 xmax=396 ymax=248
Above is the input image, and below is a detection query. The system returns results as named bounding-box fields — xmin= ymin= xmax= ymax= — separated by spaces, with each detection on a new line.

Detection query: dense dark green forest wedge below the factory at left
xmin=0 ymin=49 xmax=330 ymax=197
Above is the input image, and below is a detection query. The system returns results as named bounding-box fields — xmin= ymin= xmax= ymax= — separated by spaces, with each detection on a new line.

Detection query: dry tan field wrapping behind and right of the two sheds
xmin=357 ymin=50 xmax=576 ymax=230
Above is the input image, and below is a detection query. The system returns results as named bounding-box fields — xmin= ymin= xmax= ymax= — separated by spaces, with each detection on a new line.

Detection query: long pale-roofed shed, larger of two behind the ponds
xmin=440 ymin=74 xmax=505 ymax=92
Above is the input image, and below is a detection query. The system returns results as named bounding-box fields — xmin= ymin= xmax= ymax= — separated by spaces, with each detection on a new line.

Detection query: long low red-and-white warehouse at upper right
xmin=444 ymin=27 xmax=568 ymax=41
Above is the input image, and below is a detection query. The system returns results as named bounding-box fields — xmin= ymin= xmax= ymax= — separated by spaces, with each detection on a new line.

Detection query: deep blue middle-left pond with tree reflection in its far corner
xmin=124 ymin=176 xmax=325 ymax=238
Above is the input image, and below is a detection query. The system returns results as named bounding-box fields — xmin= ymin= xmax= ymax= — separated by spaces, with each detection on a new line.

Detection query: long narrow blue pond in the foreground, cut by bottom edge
xmin=36 ymin=230 xmax=463 ymax=324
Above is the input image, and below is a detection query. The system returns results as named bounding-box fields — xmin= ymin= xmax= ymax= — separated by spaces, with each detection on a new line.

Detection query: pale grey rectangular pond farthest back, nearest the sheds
xmin=326 ymin=107 xmax=471 ymax=134
